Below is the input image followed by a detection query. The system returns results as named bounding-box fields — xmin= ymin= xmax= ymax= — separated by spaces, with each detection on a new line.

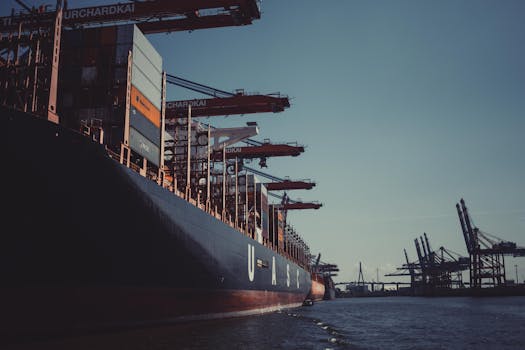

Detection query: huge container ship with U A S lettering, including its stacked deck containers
xmin=0 ymin=1 xmax=319 ymax=340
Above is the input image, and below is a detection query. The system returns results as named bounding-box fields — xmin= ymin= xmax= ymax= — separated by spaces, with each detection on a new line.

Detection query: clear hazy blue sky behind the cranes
xmin=1 ymin=0 xmax=525 ymax=281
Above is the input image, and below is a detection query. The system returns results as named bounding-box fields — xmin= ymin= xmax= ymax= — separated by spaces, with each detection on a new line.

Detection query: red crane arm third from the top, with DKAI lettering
xmin=213 ymin=144 xmax=304 ymax=160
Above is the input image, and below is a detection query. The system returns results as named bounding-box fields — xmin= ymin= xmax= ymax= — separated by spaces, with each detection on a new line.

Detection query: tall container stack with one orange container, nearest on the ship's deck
xmin=59 ymin=25 xmax=163 ymax=167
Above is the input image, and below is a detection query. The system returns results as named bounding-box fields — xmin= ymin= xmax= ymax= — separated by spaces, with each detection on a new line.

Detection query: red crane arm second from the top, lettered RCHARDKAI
xmin=166 ymin=95 xmax=290 ymax=118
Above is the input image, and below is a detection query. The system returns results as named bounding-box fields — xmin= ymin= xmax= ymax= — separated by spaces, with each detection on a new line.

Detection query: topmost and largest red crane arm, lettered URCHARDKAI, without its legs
xmin=0 ymin=0 xmax=261 ymax=34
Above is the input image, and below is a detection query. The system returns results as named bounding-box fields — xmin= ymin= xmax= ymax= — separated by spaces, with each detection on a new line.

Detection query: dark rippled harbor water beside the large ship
xmin=8 ymin=297 xmax=525 ymax=350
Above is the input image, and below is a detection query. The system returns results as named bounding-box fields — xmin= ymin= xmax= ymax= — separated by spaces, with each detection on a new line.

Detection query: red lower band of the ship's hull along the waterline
xmin=0 ymin=287 xmax=305 ymax=337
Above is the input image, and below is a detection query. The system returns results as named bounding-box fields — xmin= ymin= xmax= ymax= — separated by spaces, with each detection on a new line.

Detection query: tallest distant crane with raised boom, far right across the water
xmin=456 ymin=198 xmax=525 ymax=288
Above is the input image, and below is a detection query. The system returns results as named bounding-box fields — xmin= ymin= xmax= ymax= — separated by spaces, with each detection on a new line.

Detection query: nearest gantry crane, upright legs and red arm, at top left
xmin=0 ymin=0 xmax=261 ymax=123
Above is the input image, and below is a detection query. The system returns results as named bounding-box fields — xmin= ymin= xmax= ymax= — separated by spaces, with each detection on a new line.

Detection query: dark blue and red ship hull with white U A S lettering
xmin=0 ymin=110 xmax=311 ymax=337
